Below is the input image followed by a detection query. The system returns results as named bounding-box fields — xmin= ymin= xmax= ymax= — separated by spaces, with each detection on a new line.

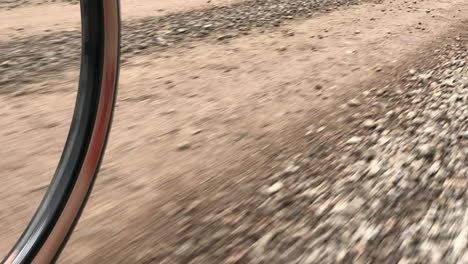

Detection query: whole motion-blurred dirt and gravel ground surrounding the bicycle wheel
xmin=0 ymin=0 xmax=468 ymax=264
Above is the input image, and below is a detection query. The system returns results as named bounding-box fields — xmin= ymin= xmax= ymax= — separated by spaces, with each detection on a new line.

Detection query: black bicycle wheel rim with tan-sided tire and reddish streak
xmin=2 ymin=0 xmax=120 ymax=264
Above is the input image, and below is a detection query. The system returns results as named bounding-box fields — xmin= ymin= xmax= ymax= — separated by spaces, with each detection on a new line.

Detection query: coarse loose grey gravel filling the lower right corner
xmin=133 ymin=36 xmax=468 ymax=264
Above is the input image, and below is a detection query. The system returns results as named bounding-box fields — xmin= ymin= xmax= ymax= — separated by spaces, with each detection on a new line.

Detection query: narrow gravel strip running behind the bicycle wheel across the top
xmin=0 ymin=0 xmax=375 ymax=91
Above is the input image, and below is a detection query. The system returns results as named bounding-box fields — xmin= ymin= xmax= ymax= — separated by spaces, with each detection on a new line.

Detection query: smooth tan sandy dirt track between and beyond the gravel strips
xmin=0 ymin=0 xmax=468 ymax=263
